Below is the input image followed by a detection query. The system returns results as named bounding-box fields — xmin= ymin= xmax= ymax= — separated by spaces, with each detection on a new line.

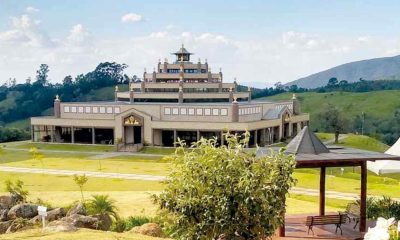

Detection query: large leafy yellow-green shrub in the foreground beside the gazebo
xmin=153 ymin=133 xmax=295 ymax=239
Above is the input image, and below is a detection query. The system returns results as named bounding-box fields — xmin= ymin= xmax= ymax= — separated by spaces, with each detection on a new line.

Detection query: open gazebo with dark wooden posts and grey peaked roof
xmin=261 ymin=126 xmax=400 ymax=237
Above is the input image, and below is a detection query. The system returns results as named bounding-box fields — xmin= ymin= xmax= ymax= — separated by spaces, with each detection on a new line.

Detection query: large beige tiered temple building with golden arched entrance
xmin=31 ymin=45 xmax=309 ymax=151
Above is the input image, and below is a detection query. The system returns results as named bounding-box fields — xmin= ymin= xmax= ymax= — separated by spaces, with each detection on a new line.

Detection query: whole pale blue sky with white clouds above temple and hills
xmin=0 ymin=0 xmax=400 ymax=87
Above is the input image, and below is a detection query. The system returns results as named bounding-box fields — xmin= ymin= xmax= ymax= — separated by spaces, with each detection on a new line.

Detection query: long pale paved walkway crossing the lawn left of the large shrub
xmin=0 ymin=166 xmax=165 ymax=181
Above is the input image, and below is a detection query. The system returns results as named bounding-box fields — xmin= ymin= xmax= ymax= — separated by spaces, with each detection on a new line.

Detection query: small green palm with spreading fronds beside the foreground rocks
xmin=88 ymin=195 xmax=119 ymax=219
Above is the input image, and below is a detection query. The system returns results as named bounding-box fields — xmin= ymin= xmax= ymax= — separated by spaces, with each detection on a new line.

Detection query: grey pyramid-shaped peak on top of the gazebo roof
xmin=286 ymin=126 xmax=329 ymax=154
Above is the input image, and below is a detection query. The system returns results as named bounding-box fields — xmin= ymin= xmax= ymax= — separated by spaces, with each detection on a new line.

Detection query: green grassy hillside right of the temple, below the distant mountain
xmin=259 ymin=90 xmax=400 ymax=129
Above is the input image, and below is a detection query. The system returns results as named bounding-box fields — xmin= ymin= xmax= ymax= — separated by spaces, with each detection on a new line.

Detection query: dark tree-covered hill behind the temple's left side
xmin=0 ymin=62 xmax=136 ymax=129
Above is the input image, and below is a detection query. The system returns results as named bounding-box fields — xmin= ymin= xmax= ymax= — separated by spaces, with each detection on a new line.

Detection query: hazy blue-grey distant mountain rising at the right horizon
xmin=285 ymin=55 xmax=400 ymax=88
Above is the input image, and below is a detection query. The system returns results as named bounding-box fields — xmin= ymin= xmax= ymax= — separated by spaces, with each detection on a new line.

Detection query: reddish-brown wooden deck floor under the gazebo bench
xmin=272 ymin=215 xmax=374 ymax=240
